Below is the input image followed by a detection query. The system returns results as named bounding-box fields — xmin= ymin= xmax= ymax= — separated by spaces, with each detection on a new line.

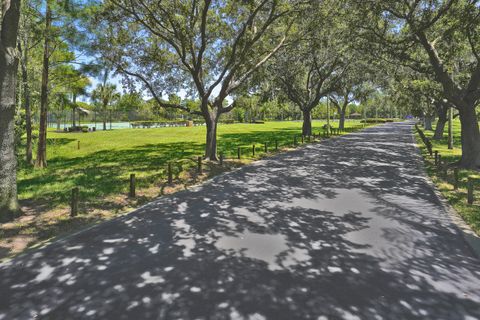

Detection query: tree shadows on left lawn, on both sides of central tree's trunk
xmin=18 ymin=124 xmax=344 ymax=208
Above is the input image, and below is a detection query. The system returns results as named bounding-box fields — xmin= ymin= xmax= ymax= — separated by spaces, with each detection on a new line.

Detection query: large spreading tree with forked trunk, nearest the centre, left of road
xmin=95 ymin=0 xmax=293 ymax=160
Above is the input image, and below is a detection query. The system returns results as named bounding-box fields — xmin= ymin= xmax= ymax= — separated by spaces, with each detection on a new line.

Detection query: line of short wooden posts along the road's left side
xmin=70 ymin=126 xmax=363 ymax=217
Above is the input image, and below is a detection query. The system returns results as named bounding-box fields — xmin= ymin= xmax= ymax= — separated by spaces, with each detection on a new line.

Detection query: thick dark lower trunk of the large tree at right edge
xmin=459 ymin=106 xmax=480 ymax=170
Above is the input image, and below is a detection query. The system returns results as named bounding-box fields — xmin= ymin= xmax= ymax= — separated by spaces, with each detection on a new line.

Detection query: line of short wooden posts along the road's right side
xmin=415 ymin=124 xmax=478 ymax=205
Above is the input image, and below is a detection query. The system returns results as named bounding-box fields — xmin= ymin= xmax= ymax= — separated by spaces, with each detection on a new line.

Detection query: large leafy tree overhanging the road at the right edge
xmin=351 ymin=0 xmax=480 ymax=169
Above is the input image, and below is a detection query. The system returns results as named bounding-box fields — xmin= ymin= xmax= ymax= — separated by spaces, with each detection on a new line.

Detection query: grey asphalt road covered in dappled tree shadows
xmin=0 ymin=124 xmax=480 ymax=320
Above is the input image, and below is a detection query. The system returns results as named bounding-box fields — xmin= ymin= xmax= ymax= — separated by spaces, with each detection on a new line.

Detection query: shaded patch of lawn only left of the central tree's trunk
xmin=18 ymin=143 xmax=201 ymax=207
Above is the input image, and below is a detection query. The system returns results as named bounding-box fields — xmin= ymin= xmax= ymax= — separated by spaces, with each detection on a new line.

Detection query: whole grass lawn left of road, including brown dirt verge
xmin=0 ymin=121 xmax=363 ymax=259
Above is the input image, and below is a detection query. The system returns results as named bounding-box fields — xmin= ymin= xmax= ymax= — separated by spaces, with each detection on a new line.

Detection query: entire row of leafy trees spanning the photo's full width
xmin=0 ymin=0 xmax=480 ymax=219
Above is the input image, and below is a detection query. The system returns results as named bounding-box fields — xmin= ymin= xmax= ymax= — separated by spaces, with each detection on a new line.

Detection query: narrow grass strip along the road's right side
xmin=416 ymin=119 xmax=480 ymax=234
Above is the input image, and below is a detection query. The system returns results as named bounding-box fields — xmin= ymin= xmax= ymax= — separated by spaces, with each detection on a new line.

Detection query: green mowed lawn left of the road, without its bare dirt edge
xmin=18 ymin=121 xmax=361 ymax=207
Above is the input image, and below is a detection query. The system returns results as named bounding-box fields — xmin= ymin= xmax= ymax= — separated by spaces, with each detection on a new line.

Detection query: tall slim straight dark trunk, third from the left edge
xmin=35 ymin=0 xmax=52 ymax=168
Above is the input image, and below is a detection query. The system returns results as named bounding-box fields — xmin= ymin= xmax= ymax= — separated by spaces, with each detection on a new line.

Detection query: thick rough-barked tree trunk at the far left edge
xmin=0 ymin=0 xmax=20 ymax=221
